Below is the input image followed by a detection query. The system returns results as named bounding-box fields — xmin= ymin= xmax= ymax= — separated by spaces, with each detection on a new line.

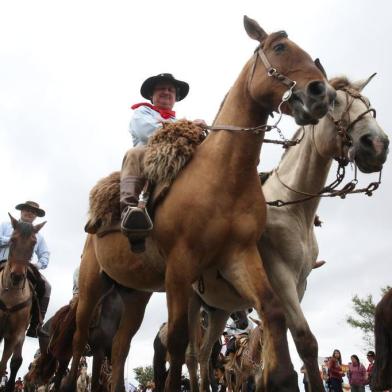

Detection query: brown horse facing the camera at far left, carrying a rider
xmin=0 ymin=215 xmax=46 ymax=392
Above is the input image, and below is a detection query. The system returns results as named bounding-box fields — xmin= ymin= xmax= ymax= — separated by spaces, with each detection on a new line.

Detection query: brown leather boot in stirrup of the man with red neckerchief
xmin=120 ymin=176 xmax=153 ymax=253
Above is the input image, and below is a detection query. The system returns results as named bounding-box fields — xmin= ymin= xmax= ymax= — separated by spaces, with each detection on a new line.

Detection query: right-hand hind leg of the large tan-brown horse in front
xmin=111 ymin=288 xmax=152 ymax=392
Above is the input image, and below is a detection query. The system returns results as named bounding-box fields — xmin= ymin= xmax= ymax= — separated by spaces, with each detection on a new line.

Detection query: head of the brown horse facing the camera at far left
xmin=8 ymin=214 xmax=46 ymax=286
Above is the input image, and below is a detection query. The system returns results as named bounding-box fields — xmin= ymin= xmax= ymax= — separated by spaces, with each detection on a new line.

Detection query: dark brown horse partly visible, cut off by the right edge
xmin=372 ymin=288 xmax=392 ymax=391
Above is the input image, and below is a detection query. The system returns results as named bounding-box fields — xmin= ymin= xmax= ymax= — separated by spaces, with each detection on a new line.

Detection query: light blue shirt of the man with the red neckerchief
xmin=128 ymin=106 xmax=176 ymax=147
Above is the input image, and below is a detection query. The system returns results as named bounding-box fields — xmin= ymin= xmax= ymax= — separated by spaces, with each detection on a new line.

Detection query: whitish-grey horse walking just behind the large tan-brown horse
xmin=188 ymin=74 xmax=389 ymax=392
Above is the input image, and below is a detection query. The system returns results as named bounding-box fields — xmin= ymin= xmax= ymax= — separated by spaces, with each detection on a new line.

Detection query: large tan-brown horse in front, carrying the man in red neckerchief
xmin=63 ymin=17 xmax=335 ymax=391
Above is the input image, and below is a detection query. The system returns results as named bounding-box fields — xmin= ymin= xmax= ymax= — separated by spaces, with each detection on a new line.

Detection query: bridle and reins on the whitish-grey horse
xmin=267 ymin=87 xmax=382 ymax=207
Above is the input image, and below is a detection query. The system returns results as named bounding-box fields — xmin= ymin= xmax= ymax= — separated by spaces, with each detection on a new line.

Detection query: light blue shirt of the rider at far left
xmin=0 ymin=222 xmax=50 ymax=269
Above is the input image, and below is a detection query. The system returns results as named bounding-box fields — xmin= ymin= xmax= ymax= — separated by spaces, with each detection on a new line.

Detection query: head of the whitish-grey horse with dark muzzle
xmin=314 ymin=75 xmax=389 ymax=173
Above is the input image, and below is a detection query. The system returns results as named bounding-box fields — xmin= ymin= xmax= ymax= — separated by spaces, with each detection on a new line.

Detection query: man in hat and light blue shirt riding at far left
xmin=0 ymin=201 xmax=51 ymax=338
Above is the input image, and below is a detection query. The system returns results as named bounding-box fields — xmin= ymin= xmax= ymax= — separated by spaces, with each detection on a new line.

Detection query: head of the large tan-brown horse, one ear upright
xmin=244 ymin=16 xmax=335 ymax=125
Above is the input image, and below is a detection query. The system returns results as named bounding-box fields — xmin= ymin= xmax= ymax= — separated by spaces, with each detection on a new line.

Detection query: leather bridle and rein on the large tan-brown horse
xmin=203 ymin=45 xmax=300 ymax=148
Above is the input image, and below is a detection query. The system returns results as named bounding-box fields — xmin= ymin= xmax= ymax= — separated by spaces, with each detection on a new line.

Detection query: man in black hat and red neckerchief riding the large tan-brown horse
xmin=120 ymin=73 xmax=205 ymax=252
